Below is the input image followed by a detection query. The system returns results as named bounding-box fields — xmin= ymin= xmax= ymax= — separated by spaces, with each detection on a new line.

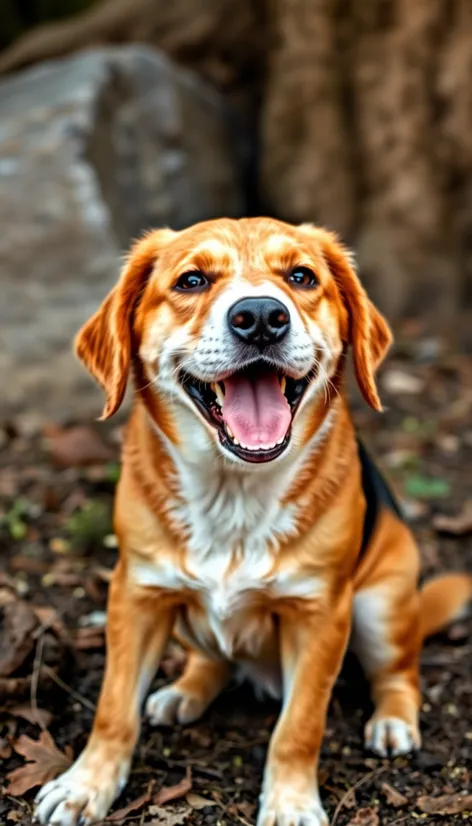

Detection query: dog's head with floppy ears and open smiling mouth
xmin=77 ymin=218 xmax=391 ymax=464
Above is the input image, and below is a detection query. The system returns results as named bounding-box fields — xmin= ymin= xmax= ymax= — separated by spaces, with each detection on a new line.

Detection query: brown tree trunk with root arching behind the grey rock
xmin=0 ymin=0 xmax=472 ymax=326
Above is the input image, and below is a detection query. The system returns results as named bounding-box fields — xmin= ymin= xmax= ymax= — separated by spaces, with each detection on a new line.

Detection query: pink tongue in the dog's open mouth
xmin=222 ymin=371 xmax=291 ymax=448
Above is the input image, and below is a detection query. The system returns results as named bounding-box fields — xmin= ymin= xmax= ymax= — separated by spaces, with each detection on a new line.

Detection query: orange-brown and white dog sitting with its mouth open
xmin=36 ymin=218 xmax=472 ymax=826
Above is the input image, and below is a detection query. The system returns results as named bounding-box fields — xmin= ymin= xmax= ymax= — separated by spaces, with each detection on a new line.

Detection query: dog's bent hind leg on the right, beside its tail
xmin=352 ymin=511 xmax=422 ymax=756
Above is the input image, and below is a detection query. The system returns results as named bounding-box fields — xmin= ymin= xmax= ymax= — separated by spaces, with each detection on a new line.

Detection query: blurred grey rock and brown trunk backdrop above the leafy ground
xmin=0 ymin=0 xmax=472 ymax=416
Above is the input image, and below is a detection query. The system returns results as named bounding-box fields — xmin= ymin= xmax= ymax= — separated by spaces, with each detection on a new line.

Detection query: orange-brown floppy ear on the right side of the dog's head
xmin=304 ymin=227 xmax=392 ymax=410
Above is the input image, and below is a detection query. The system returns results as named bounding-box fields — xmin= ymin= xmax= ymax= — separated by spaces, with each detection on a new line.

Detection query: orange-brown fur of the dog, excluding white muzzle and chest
xmin=35 ymin=219 xmax=472 ymax=826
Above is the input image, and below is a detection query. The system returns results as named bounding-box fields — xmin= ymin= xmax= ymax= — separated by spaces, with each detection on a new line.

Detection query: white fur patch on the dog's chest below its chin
xmin=133 ymin=444 xmax=322 ymax=657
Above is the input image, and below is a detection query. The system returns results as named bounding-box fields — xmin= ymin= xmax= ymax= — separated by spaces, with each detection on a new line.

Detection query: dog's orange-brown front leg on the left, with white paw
xmin=36 ymin=565 xmax=174 ymax=826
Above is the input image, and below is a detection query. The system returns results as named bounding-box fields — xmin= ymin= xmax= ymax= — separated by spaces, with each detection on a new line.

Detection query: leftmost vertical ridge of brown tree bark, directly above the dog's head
xmin=261 ymin=0 xmax=354 ymax=237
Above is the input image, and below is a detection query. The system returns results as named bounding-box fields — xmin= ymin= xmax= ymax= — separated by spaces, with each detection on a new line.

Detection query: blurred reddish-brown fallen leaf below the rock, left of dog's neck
xmin=43 ymin=425 xmax=116 ymax=468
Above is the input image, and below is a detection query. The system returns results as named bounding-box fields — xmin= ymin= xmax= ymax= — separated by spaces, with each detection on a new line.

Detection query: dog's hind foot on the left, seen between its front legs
xmin=146 ymin=649 xmax=232 ymax=726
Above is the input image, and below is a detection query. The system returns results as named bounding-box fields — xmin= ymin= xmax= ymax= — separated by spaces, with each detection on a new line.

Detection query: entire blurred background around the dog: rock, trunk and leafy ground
xmin=0 ymin=0 xmax=472 ymax=826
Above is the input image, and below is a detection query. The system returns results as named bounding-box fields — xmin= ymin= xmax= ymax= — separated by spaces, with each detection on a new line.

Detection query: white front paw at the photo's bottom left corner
xmin=35 ymin=758 xmax=129 ymax=826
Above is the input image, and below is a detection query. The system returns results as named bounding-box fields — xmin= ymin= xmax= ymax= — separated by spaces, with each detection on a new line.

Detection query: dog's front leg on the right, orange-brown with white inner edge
xmin=258 ymin=585 xmax=351 ymax=826
